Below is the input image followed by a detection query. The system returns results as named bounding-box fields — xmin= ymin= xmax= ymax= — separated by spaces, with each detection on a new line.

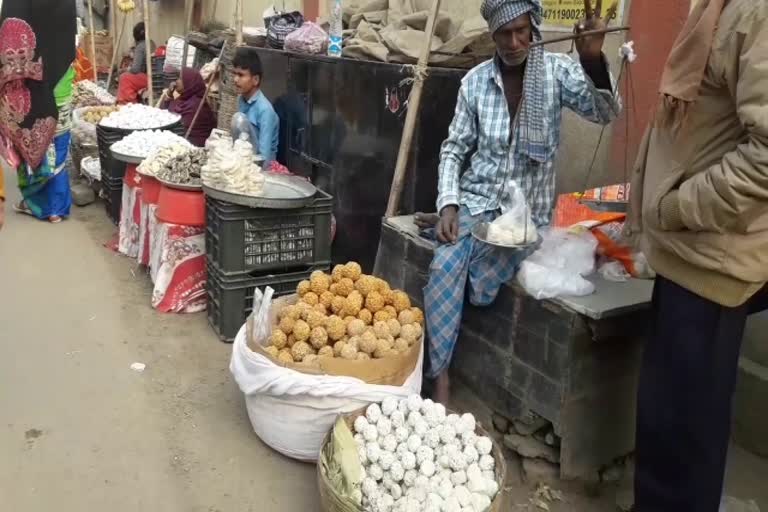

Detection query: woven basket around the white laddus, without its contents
xmin=317 ymin=408 xmax=508 ymax=512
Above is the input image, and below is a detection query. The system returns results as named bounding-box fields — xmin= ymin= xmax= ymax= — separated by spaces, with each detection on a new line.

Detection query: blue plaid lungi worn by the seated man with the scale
xmin=424 ymin=206 xmax=527 ymax=378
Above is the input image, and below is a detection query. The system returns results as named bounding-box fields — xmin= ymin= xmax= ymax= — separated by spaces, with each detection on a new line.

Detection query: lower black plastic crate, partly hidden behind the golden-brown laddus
xmin=206 ymin=264 xmax=329 ymax=343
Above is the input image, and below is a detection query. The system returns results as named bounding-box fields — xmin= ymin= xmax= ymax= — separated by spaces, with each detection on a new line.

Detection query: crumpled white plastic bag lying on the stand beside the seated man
xmin=517 ymin=229 xmax=597 ymax=300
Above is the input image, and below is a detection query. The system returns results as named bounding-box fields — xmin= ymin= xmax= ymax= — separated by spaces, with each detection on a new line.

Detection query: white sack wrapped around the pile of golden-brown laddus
xmin=229 ymin=288 xmax=424 ymax=462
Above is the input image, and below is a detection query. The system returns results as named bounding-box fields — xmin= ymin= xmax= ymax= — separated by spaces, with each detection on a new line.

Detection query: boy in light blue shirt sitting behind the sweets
xmin=232 ymin=48 xmax=280 ymax=169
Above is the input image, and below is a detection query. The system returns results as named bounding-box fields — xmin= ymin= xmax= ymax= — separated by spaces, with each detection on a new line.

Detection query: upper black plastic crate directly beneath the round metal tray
xmin=205 ymin=190 xmax=333 ymax=274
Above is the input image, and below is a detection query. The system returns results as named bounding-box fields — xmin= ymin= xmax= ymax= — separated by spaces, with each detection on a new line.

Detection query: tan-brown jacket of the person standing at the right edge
xmin=628 ymin=0 xmax=768 ymax=307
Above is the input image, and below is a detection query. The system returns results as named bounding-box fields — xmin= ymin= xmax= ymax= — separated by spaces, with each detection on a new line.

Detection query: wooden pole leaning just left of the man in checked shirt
xmin=387 ymin=0 xmax=440 ymax=217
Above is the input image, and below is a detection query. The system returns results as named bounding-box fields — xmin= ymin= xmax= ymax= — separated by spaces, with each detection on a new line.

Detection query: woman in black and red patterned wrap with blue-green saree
xmin=0 ymin=0 xmax=76 ymax=223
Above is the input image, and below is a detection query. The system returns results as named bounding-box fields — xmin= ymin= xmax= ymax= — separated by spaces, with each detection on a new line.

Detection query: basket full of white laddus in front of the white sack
xmin=318 ymin=395 xmax=507 ymax=512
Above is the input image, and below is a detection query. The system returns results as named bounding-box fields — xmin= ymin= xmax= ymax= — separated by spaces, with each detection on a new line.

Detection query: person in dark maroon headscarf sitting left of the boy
xmin=164 ymin=68 xmax=217 ymax=147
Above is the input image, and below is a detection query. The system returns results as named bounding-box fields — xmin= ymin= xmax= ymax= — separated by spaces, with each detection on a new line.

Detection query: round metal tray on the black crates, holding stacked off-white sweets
xmin=203 ymin=173 xmax=317 ymax=210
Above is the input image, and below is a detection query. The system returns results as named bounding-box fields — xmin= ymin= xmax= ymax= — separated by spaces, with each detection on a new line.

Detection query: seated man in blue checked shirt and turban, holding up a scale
xmin=422 ymin=0 xmax=620 ymax=403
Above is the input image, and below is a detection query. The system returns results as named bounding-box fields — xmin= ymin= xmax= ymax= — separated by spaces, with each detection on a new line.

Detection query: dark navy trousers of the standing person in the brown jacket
xmin=635 ymin=276 xmax=764 ymax=512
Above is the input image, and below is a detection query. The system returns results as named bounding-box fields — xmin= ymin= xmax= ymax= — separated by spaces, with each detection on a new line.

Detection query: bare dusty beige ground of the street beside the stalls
xmin=0 ymin=166 xmax=768 ymax=512
